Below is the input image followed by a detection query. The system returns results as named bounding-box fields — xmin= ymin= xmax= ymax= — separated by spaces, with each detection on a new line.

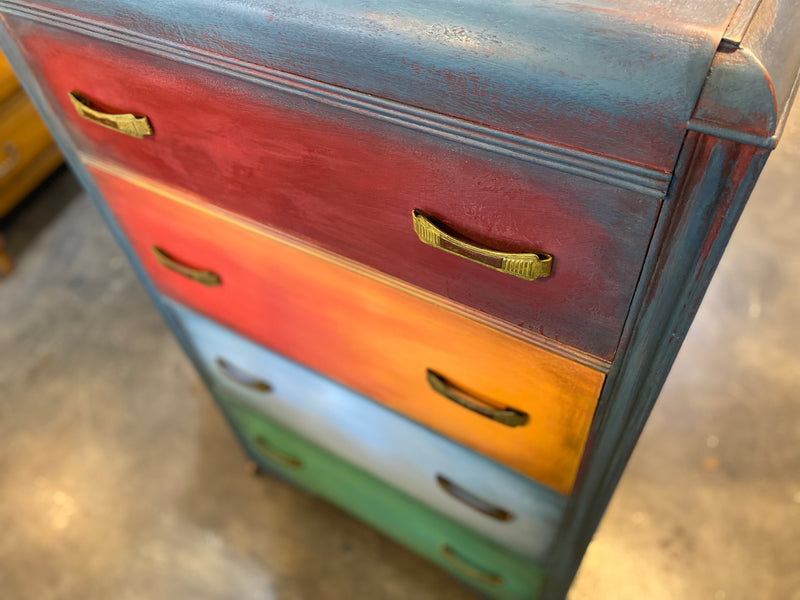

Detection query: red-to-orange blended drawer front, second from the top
xmin=92 ymin=168 xmax=604 ymax=493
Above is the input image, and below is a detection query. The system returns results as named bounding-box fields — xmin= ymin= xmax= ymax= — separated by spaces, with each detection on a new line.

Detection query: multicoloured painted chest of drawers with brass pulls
xmin=0 ymin=0 xmax=800 ymax=600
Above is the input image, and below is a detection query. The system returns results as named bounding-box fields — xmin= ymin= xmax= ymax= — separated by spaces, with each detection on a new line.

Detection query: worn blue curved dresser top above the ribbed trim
xmin=2 ymin=0 xmax=738 ymax=171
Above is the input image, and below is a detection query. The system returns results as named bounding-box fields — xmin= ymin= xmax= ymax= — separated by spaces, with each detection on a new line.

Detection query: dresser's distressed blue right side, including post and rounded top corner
xmin=543 ymin=8 xmax=800 ymax=600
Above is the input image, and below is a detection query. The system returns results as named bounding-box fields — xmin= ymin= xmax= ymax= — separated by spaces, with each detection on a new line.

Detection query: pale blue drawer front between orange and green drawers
xmin=165 ymin=300 xmax=565 ymax=561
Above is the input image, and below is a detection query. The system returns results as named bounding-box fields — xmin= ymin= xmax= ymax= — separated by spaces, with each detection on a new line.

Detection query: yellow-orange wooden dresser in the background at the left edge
xmin=0 ymin=55 xmax=62 ymax=275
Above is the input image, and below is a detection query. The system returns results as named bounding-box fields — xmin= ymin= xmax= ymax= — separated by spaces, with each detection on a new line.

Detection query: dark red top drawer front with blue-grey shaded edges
xmin=10 ymin=19 xmax=659 ymax=359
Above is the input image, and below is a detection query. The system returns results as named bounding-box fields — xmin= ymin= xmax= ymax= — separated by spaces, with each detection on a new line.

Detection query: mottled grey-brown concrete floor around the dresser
xmin=0 ymin=111 xmax=800 ymax=600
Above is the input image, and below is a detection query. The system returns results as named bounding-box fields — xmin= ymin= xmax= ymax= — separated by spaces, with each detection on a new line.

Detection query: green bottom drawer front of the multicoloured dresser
xmin=221 ymin=398 xmax=543 ymax=600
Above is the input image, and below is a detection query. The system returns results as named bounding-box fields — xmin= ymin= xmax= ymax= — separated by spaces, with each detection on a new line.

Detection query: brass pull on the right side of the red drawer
xmin=411 ymin=209 xmax=553 ymax=281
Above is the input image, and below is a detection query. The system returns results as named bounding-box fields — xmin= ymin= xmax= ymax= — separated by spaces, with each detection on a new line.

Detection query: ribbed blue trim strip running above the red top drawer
xmin=0 ymin=0 xmax=671 ymax=198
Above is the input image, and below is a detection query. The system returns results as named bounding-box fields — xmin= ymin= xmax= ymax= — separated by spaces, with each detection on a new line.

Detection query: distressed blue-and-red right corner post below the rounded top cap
xmin=542 ymin=132 xmax=769 ymax=600
